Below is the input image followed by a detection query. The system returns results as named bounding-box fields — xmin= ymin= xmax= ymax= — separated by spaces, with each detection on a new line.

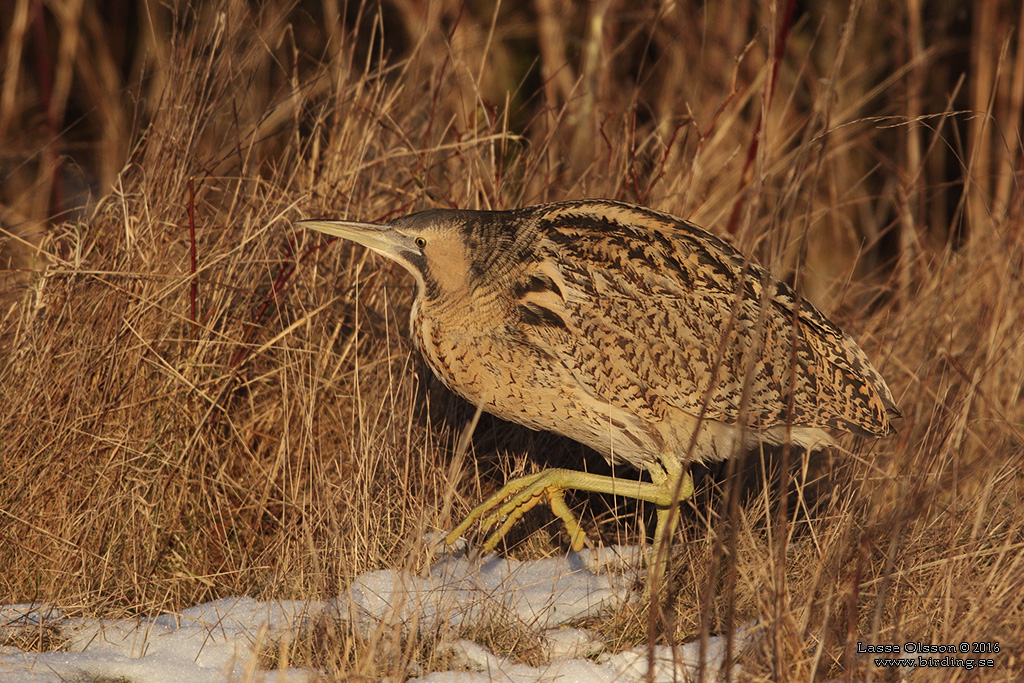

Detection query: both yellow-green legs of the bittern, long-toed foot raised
xmin=446 ymin=456 xmax=693 ymax=589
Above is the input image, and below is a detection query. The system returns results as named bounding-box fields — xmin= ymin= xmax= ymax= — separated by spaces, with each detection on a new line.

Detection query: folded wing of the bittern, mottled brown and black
xmin=532 ymin=203 xmax=898 ymax=435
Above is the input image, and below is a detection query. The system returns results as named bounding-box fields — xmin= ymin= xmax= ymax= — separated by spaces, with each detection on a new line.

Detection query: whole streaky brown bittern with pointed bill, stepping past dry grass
xmin=296 ymin=199 xmax=900 ymax=583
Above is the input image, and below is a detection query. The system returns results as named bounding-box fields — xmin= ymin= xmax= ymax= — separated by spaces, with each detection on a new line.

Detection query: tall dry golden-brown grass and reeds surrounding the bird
xmin=0 ymin=0 xmax=1024 ymax=680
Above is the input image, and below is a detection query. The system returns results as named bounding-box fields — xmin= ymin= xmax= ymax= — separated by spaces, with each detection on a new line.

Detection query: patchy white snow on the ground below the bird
xmin=0 ymin=547 xmax=749 ymax=683
